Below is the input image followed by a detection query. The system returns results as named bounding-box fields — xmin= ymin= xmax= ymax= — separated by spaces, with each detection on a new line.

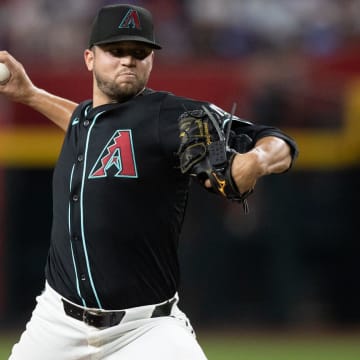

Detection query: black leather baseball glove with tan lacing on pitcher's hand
xmin=178 ymin=108 xmax=253 ymax=208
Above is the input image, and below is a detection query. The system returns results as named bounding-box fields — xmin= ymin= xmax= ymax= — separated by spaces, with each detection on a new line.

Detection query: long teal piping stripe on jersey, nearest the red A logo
xmin=80 ymin=111 xmax=105 ymax=309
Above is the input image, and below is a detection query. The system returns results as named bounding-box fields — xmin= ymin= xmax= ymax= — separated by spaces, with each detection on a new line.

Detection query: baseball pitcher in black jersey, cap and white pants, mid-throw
xmin=0 ymin=5 xmax=297 ymax=360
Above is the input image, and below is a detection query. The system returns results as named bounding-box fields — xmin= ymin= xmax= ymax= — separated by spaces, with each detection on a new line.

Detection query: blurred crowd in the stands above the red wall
xmin=0 ymin=0 xmax=360 ymax=63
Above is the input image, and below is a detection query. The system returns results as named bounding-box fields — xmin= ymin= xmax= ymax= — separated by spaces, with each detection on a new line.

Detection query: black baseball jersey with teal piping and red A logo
xmin=46 ymin=89 xmax=296 ymax=309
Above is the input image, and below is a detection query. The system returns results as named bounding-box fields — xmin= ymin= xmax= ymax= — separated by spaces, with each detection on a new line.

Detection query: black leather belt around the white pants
xmin=61 ymin=298 xmax=176 ymax=329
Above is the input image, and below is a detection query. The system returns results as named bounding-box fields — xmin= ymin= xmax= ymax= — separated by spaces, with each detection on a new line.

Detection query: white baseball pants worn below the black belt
xmin=9 ymin=284 xmax=206 ymax=360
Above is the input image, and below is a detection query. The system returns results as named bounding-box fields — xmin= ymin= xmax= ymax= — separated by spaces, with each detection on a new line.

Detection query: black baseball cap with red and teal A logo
xmin=89 ymin=4 xmax=161 ymax=49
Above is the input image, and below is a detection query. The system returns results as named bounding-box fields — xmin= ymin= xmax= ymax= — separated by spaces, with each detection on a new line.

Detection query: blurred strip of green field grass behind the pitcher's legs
xmin=0 ymin=332 xmax=360 ymax=360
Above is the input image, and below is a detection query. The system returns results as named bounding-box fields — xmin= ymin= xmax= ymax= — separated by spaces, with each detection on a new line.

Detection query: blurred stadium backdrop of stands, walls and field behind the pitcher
xmin=0 ymin=0 xmax=360 ymax=360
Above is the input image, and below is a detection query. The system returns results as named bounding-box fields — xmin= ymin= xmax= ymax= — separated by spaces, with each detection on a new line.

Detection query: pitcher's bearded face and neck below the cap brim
xmin=84 ymin=41 xmax=154 ymax=106
